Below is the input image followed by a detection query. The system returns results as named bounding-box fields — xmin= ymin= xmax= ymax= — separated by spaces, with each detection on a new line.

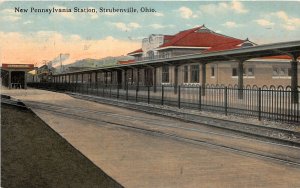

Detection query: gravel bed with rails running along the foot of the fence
xmin=72 ymin=95 xmax=300 ymax=145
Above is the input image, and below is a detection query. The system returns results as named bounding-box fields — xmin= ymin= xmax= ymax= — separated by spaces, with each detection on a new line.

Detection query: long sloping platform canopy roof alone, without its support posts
xmin=61 ymin=40 xmax=300 ymax=72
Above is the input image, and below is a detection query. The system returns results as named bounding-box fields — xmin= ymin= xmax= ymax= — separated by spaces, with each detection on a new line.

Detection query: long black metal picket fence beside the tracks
xmin=28 ymin=83 xmax=300 ymax=122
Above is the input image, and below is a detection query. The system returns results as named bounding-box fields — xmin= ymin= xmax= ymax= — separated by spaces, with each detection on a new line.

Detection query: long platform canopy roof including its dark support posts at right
xmin=55 ymin=40 xmax=300 ymax=101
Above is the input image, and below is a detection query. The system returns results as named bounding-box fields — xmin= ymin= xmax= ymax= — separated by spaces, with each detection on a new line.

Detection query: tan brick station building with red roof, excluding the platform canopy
xmin=120 ymin=25 xmax=300 ymax=87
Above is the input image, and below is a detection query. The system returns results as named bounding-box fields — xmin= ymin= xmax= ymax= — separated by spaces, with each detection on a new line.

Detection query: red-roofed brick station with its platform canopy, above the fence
xmin=53 ymin=25 xmax=300 ymax=100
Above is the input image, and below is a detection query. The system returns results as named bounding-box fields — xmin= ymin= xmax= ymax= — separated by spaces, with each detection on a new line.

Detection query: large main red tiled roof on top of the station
xmin=160 ymin=26 xmax=243 ymax=47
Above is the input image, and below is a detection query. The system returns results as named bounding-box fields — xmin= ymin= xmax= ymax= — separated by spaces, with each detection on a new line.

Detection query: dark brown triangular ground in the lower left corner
xmin=1 ymin=104 xmax=122 ymax=188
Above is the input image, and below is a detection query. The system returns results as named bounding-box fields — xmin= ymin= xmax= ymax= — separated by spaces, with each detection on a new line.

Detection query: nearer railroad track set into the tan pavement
xmin=19 ymin=101 xmax=300 ymax=166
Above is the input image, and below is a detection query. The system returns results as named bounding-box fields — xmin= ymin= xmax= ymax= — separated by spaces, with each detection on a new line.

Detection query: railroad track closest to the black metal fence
xmin=71 ymin=94 xmax=300 ymax=147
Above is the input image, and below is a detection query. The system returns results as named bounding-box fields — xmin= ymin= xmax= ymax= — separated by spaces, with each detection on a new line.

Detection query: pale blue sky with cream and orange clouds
xmin=0 ymin=0 xmax=300 ymax=64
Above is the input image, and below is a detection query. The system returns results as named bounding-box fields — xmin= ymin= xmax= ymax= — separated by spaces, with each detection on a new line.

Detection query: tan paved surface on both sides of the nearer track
xmin=2 ymin=89 xmax=300 ymax=188
